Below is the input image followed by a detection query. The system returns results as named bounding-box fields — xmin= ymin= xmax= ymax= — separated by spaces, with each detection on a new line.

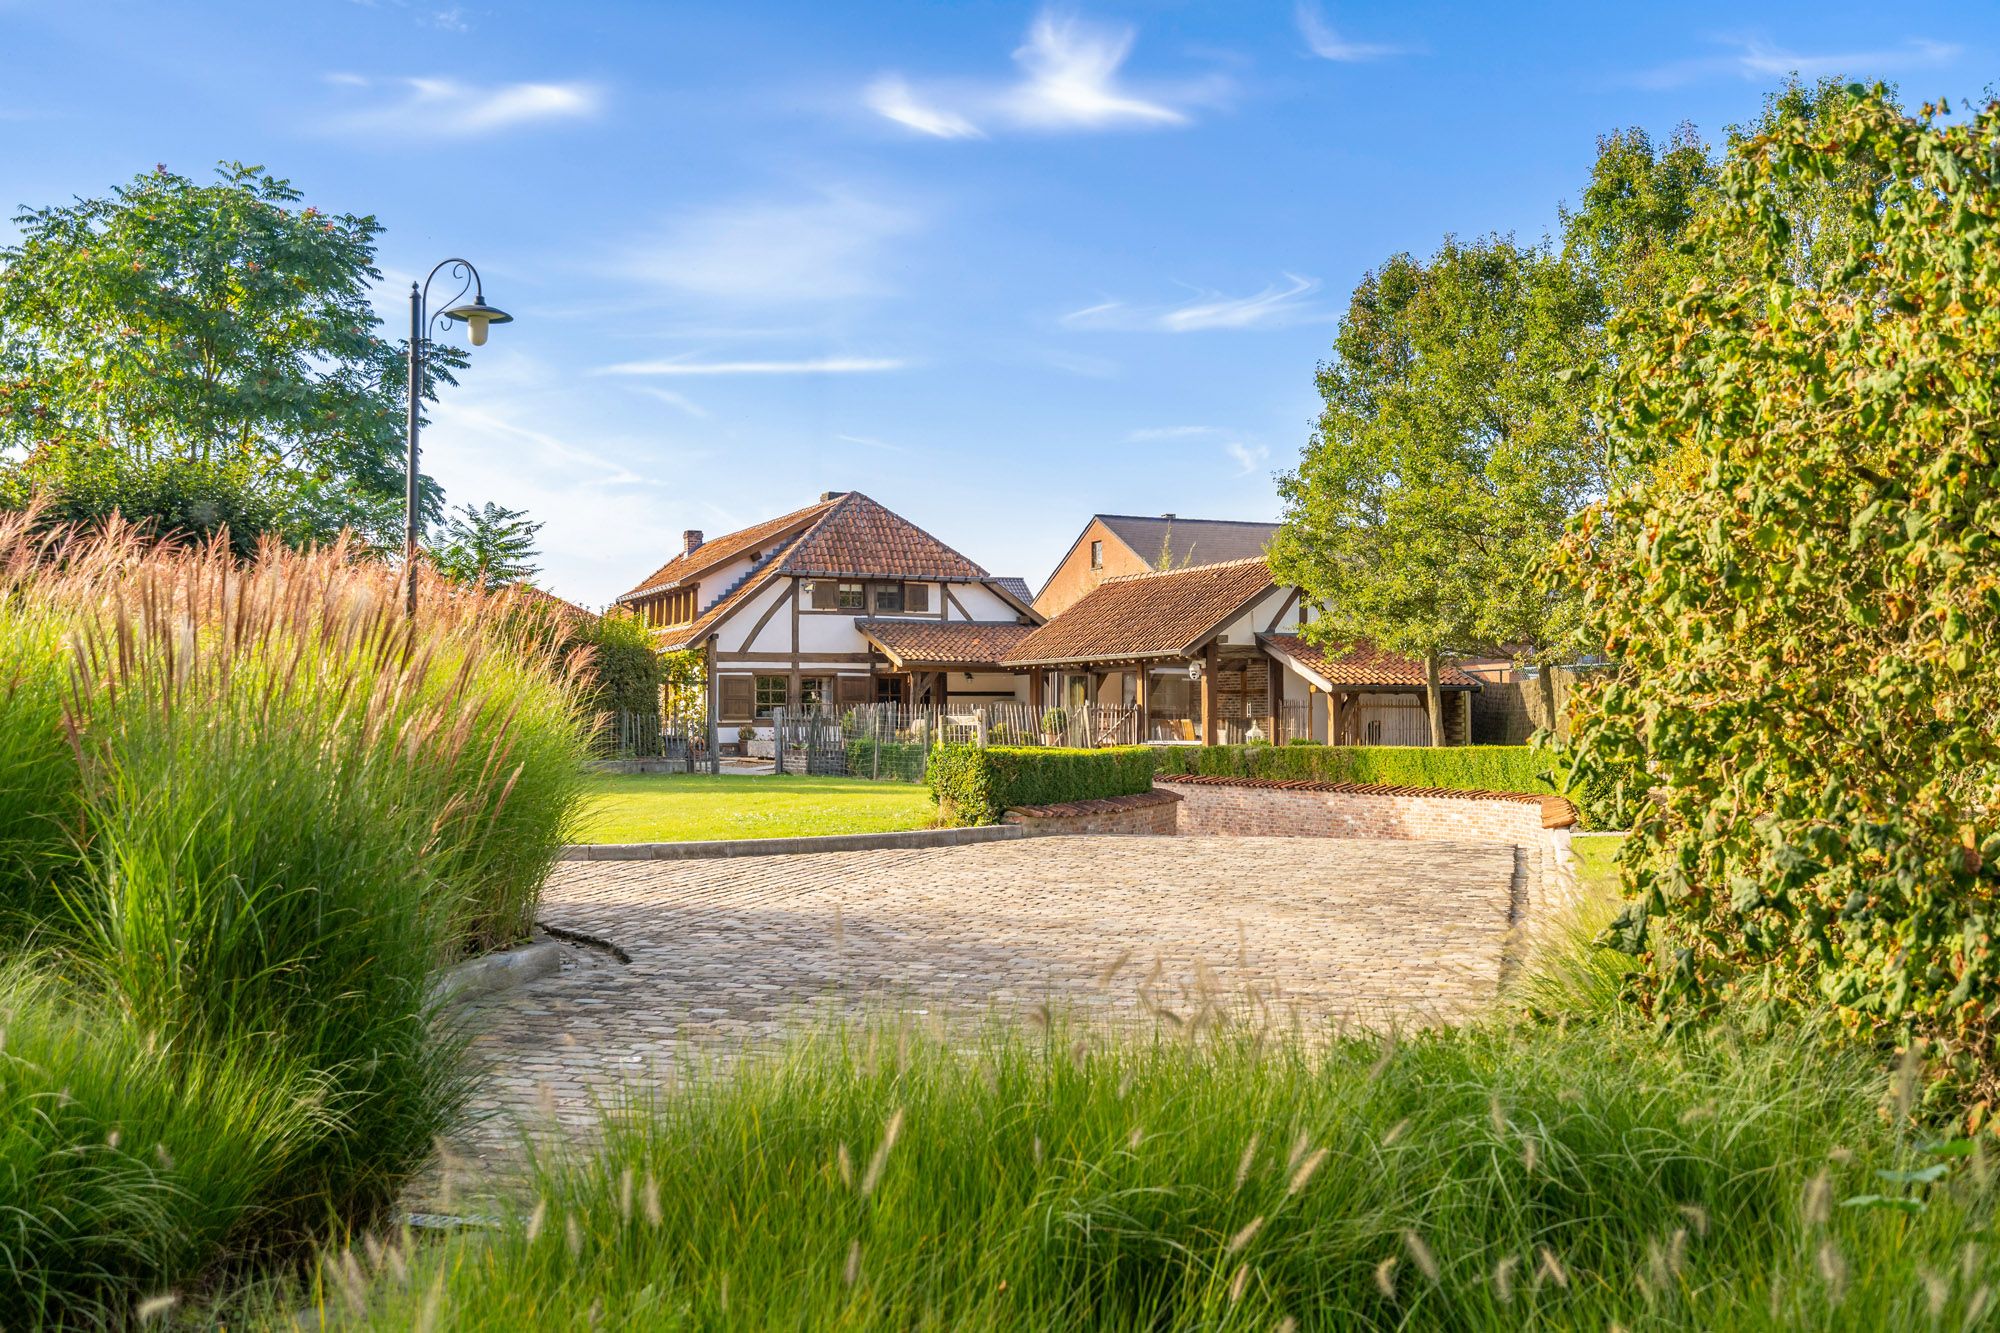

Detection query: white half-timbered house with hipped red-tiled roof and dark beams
xmin=618 ymin=490 xmax=1040 ymax=729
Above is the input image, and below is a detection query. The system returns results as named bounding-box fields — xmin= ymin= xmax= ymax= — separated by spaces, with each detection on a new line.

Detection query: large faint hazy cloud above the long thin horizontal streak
xmin=612 ymin=186 xmax=924 ymax=308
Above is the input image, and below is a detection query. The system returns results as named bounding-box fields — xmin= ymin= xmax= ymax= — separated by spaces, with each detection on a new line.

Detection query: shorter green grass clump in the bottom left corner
xmin=0 ymin=959 xmax=336 ymax=1329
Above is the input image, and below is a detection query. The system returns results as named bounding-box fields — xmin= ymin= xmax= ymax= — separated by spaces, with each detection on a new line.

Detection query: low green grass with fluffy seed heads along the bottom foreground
xmin=296 ymin=1008 xmax=2000 ymax=1329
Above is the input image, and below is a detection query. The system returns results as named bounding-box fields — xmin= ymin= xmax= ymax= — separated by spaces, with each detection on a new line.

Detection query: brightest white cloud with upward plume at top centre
xmin=862 ymin=10 xmax=1228 ymax=138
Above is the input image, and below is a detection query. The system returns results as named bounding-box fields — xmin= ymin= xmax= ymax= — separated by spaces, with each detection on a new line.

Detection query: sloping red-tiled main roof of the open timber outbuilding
xmin=1008 ymin=556 xmax=1272 ymax=667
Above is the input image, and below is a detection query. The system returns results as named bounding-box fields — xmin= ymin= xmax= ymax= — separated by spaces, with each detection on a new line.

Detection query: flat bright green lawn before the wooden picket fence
xmin=578 ymin=773 xmax=938 ymax=843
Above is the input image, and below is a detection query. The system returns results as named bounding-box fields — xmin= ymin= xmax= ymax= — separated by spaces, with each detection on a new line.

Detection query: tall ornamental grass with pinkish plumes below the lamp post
xmin=0 ymin=510 xmax=584 ymax=1323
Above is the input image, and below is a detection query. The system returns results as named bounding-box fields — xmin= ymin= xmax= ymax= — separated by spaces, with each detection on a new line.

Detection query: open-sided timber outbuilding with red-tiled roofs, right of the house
xmin=1004 ymin=556 xmax=1478 ymax=745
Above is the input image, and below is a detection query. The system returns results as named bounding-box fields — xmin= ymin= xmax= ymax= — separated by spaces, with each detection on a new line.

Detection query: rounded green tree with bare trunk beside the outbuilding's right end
xmin=1272 ymin=238 xmax=1598 ymax=743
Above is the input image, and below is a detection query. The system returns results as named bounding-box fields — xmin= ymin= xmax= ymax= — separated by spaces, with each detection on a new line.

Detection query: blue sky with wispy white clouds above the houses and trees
xmin=0 ymin=0 xmax=2000 ymax=604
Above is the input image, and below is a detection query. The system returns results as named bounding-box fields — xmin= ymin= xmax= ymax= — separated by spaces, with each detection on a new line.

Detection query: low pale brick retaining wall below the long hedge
xmin=1154 ymin=773 xmax=1576 ymax=921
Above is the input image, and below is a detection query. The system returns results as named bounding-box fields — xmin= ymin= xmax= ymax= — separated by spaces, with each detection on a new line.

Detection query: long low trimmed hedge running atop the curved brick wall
xmin=1154 ymin=745 xmax=1556 ymax=795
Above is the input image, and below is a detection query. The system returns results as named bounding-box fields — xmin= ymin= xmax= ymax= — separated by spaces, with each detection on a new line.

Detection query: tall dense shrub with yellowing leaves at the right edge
xmin=1566 ymin=86 xmax=2000 ymax=1099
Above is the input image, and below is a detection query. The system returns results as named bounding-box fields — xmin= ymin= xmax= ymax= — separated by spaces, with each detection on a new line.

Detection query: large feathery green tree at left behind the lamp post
xmin=0 ymin=162 xmax=464 ymax=542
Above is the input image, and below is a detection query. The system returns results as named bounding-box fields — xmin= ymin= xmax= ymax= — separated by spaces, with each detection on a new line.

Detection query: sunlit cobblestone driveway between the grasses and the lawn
xmin=430 ymin=837 xmax=1514 ymax=1192
